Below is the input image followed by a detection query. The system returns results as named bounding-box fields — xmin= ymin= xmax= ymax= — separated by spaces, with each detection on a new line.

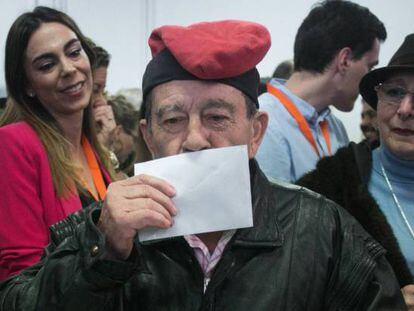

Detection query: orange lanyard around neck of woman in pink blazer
xmin=81 ymin=135 xmax=106 ymax=201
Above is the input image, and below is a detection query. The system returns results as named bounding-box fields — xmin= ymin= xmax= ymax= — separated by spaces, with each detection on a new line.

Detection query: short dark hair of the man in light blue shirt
xmin=294 ymin=0 xmax=387 ymax=73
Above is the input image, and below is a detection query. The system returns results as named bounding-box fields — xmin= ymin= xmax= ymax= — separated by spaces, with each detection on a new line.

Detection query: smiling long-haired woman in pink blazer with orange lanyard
xmin=0 ymin=7 xmax=115 ymax=280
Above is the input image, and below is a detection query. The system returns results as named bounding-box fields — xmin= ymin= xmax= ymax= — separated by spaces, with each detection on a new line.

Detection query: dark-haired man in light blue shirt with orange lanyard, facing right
xmin=257 ymin=1 xmax=387 ymax=182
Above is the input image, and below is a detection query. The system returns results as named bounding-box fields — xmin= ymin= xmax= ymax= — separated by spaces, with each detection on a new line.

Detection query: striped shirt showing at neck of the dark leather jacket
xmin=184 ymin=230 xmax=236 ymax=291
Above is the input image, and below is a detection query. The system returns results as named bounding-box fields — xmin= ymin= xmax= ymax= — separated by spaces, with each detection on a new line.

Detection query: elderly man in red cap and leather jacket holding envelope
xmin=0 ymin=20 xmax=404 ymax=311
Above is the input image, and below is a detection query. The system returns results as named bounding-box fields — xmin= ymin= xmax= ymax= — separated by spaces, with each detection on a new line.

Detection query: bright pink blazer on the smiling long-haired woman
xmin=0 ymin=122 xmax=110 ymax=280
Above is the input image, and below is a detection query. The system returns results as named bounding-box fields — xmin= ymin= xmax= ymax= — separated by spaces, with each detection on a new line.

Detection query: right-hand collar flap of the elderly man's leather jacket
xmin=232 ymin=159 xmax=283 ymax=248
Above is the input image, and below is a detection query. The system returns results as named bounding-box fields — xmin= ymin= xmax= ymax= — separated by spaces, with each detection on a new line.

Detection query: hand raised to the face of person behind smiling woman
xmin=93 ymin=105 xmax=116 ymax=148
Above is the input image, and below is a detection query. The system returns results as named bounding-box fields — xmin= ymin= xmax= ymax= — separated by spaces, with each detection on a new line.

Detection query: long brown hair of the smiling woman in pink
xmin=0 ymin=7 xmax=115 ymax=197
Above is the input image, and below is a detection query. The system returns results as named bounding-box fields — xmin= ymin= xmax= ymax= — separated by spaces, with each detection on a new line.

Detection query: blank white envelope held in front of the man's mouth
xmin=135 ymin=145 xmax=253 ymax=241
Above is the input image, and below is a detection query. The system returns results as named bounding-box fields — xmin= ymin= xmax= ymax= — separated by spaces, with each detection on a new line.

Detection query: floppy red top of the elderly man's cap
xmin=148 ymin=20 xmax=270 ymax=80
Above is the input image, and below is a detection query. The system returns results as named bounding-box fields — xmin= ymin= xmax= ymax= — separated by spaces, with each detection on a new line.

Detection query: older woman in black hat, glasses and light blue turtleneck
xmin=298 ymin=34 xmax=414 ymax=310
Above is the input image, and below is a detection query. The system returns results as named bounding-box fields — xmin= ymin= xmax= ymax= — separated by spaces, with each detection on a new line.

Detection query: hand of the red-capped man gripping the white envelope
xmin=98 ymin=175 xmax=177 ymax=259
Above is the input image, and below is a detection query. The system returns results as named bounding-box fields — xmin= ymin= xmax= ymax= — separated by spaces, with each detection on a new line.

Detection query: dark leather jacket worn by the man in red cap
xmin=0 ymin=161 xmax=405 ymax=311
